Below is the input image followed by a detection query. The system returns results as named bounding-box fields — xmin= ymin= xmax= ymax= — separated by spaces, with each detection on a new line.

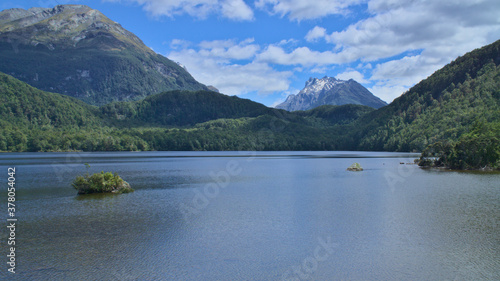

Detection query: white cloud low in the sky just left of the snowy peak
xmin=168 ymin=39 xmax=293 ymax=95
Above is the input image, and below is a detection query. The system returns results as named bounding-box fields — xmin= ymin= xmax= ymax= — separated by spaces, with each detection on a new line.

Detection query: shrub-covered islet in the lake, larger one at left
xmin=72 ymin=172 xmax=134 ymax=194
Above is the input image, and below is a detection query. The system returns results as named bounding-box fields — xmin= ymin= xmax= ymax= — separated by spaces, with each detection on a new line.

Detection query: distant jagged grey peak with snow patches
xmin=276 ymin=76 xmax=387 ymax=111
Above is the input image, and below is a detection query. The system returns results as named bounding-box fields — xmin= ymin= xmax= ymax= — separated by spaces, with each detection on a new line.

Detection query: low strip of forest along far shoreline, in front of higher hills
xmin=0 ymin=115 xmax=341 ymax=151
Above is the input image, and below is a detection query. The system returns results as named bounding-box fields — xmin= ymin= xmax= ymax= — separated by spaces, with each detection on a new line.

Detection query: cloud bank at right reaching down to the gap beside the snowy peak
xmin=320 ymin=0 xmax=500 ymax=102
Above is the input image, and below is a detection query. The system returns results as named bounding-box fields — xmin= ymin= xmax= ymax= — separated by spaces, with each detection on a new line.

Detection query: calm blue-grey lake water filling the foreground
xmin=0 ymin=152 xmax=500 ymax=280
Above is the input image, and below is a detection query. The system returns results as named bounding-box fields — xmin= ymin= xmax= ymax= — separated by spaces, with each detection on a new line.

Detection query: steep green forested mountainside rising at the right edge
xmin=344 ymin=40 xmax=500 ymax=151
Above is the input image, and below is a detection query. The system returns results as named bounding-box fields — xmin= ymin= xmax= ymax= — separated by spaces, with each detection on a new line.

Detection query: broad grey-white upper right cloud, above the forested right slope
xmin=325 ymin=0 xmax=500 ymax=61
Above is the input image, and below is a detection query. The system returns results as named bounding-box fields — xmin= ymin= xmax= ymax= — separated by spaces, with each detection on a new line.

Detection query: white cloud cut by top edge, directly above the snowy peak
xmin=255 ymin=0 xmax=363 ymax=21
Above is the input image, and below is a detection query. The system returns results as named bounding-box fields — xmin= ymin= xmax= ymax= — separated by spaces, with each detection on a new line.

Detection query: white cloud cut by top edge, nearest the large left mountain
xmin=104 ymin=0 xmax=254 ymax=21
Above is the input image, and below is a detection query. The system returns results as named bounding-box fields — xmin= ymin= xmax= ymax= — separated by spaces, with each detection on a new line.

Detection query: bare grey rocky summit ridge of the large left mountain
xmin=0 ymin=5 xmax=150 ymax=54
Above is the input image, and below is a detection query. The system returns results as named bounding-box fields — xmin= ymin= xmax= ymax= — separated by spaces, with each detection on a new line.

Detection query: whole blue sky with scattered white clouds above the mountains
xmin=0 ymin=0 xmax=500 ymax=106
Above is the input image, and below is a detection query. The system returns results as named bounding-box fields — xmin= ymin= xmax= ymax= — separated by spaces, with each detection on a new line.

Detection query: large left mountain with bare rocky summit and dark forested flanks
xmin=0 ymin=5 xmax=208 ymax=105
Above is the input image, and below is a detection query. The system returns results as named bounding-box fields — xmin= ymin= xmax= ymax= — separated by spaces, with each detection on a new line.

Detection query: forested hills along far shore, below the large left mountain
xmin=0 ymin=71 xmax=348 ymax=151
